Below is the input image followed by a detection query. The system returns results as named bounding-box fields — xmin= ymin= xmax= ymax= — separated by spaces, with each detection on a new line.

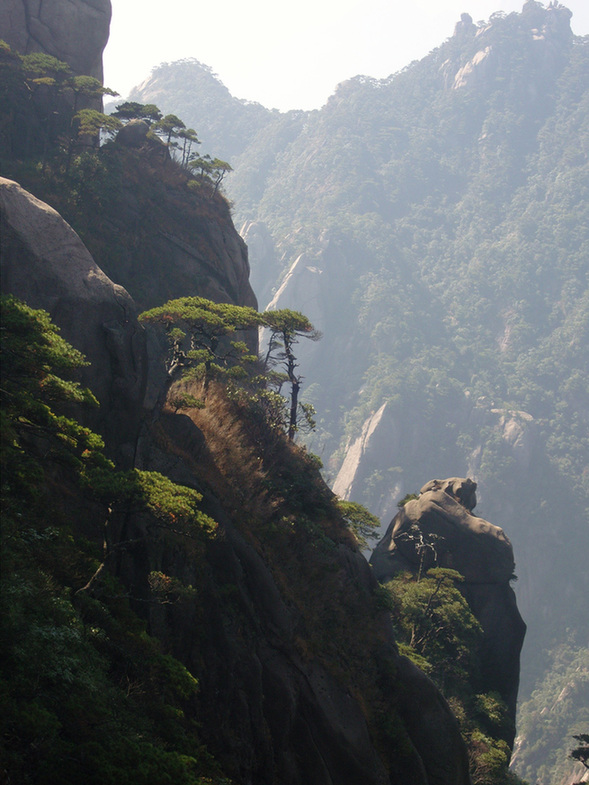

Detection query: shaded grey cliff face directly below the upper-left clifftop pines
xmin=71 ymin=139 xmax=257 ymax=309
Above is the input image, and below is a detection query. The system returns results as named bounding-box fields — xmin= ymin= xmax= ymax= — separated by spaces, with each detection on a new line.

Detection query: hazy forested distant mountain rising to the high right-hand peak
xmin=129 ymin=0 xmax=589 ymax=785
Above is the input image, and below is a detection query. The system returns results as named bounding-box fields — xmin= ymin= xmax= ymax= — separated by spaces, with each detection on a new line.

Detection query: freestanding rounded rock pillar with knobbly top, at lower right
xmin=370 ymin=477 xmax=526 ymax=745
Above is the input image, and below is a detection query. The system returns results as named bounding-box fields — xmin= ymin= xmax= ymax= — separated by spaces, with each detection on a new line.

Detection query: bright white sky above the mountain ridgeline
xmin=104 ymin=0 xmax=589 ymax=111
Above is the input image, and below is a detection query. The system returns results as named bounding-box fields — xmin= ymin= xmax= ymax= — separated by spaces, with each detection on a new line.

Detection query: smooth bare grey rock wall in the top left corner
xmin=0 ymin=0 xmax=112 ymax=81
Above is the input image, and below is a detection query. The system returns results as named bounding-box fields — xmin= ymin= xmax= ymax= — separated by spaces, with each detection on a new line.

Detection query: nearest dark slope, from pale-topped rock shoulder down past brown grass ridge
xmin=0 ymin=175 xmax=469 ymax=785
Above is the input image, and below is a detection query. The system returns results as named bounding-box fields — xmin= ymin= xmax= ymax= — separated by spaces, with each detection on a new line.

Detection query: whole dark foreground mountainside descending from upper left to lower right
xmin=0 ymin=7 xmax=528 ymax=785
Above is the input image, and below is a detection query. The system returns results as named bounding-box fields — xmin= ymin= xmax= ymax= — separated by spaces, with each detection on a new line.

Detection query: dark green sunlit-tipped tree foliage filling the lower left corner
xmin=0 ymin=297 xmax=227 ymax=785
